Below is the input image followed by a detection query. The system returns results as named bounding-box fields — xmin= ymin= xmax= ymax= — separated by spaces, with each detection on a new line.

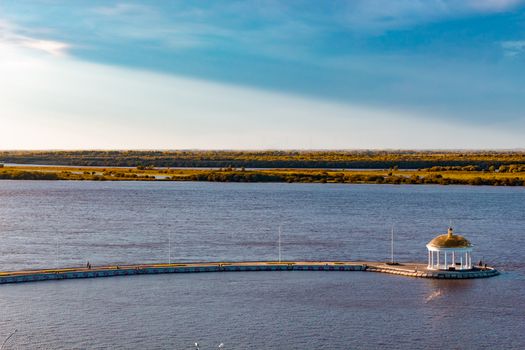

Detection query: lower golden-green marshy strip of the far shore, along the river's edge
xmin=0 ymin=166 xmax=525 ymax=186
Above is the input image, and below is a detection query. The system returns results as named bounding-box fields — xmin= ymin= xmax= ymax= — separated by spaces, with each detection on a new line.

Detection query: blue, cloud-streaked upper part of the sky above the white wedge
xmin=0 ymin=0 xmax=525 ymax=142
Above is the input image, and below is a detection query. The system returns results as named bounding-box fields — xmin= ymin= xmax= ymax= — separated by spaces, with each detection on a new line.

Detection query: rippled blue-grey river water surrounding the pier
xmin=0 ymin=181 xmax=525 ymax=350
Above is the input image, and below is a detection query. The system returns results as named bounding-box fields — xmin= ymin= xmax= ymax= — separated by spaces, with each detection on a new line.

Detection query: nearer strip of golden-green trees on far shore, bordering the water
xmin=0 ymin=168 xmax=525 ymax=186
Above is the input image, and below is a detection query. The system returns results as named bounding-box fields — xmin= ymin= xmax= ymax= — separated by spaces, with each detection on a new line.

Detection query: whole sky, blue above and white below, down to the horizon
xmin=0 ymin=0 xmax=525 ymax=150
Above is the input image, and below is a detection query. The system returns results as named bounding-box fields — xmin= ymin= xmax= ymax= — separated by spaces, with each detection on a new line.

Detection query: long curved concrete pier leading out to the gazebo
xmin=0 ymin=261 xmax=499 ymax=284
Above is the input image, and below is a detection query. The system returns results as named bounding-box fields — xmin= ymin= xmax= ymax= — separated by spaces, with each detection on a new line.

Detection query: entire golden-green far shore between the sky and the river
xmin=0 ymin=150 xmax=525 ymax=186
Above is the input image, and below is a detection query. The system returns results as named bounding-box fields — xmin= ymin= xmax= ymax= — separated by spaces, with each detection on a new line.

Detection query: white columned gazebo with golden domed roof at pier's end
xmin=427 ymin=227 xmax=472 ymax=270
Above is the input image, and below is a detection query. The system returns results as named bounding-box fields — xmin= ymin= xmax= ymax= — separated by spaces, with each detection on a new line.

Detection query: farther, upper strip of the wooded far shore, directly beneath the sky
xmin=0 ymin=150 xmax=525 ymax=170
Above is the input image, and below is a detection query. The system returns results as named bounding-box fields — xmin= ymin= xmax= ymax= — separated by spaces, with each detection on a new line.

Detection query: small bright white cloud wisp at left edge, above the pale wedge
xmin=0 ymin=20 xmax=70 ymax=56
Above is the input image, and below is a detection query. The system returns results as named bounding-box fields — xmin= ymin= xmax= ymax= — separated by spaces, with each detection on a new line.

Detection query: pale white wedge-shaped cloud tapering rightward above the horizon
xmin=0 ymin=41 xmax=523 ymax=149
